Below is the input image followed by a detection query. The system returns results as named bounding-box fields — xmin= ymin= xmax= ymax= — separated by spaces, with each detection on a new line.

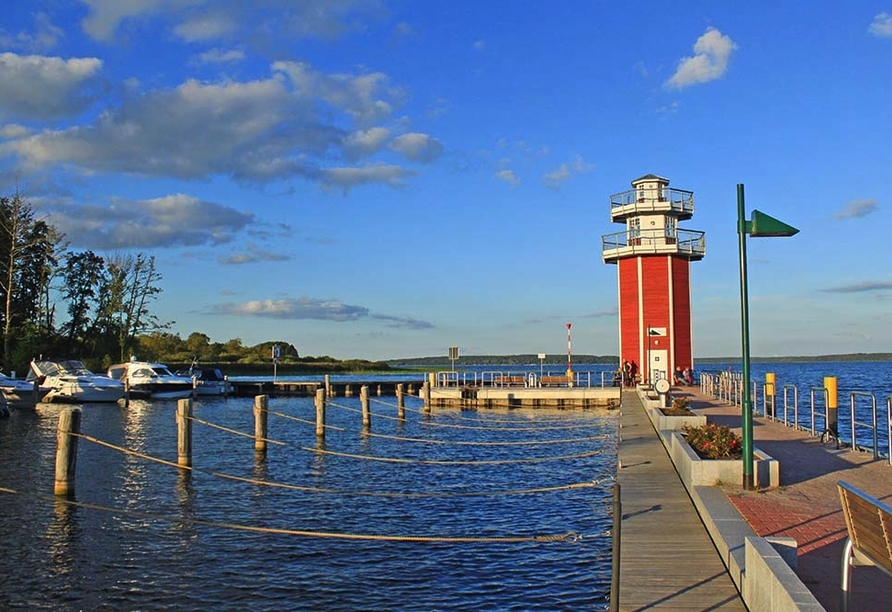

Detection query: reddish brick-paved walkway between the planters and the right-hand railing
xmin=676 ymin=387 xmax=892 ymax=611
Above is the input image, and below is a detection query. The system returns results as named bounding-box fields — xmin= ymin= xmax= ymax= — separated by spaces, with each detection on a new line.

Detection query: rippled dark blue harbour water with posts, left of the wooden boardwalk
xmin=0 ymin=384 xmax=616 ymax=611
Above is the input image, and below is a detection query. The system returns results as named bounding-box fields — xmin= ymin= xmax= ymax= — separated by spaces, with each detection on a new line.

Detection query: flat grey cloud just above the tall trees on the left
xmin=35 ymin=194 xmax=254 ymax=250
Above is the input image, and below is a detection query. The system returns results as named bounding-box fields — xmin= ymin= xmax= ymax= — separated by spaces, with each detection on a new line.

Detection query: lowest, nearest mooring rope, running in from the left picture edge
xmin=0 ymin=487 xmax=584 ymax=543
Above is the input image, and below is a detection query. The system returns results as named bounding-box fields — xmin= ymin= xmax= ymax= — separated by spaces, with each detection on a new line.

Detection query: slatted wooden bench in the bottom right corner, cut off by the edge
xmin=837 ymin=480 xmax=892 ymax=612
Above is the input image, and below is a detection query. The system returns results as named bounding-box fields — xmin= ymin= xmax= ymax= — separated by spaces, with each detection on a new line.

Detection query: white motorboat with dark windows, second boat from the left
xmin=25 ymin=359 xmax=124 ymax=403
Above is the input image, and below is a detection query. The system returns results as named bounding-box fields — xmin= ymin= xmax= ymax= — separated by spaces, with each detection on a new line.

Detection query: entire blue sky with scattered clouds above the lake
xmin=0 ymin=0 xmax=892 ymax=359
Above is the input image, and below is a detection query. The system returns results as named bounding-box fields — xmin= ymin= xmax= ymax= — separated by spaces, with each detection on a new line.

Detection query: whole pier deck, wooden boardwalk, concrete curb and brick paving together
xmin=615 ymin=387 xmax=892 ymax=612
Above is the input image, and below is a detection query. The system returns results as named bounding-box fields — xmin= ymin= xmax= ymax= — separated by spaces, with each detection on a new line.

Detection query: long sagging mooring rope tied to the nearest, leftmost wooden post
xmin=71 ymin=432 xmax=614 ymax=498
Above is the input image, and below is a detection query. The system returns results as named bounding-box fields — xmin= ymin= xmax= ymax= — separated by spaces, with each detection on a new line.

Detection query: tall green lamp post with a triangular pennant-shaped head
xmin=737 ymin=183 xmax=799 ymax=491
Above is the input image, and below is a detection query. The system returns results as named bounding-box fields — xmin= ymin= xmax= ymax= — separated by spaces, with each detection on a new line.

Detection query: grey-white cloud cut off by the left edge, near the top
xmin=0 ymin=53 xmax=104 ymax=119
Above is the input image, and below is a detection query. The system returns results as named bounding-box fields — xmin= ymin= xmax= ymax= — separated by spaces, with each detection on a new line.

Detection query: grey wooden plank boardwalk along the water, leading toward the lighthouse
xmin=617 ymin=391 xmax=746 ymax=610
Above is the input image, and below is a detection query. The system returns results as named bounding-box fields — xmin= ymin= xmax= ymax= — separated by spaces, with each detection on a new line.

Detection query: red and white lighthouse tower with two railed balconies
xmin=601 ymin=174 xmax=706 ymax=384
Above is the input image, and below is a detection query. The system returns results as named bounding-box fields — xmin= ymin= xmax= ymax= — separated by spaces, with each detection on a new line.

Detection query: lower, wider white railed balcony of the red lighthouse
xmin=601 ymin=228 xmax=706 ymax=263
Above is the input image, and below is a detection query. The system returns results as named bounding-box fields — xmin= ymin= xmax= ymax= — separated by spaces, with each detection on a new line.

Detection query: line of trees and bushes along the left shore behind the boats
xmin=0 ymin=192 xmax=388 ymax=372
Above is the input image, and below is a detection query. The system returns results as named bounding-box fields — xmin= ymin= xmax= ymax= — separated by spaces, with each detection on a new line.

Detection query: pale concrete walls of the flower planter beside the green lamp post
xmin=666 ymin=432 xmax=780 ymax=489
